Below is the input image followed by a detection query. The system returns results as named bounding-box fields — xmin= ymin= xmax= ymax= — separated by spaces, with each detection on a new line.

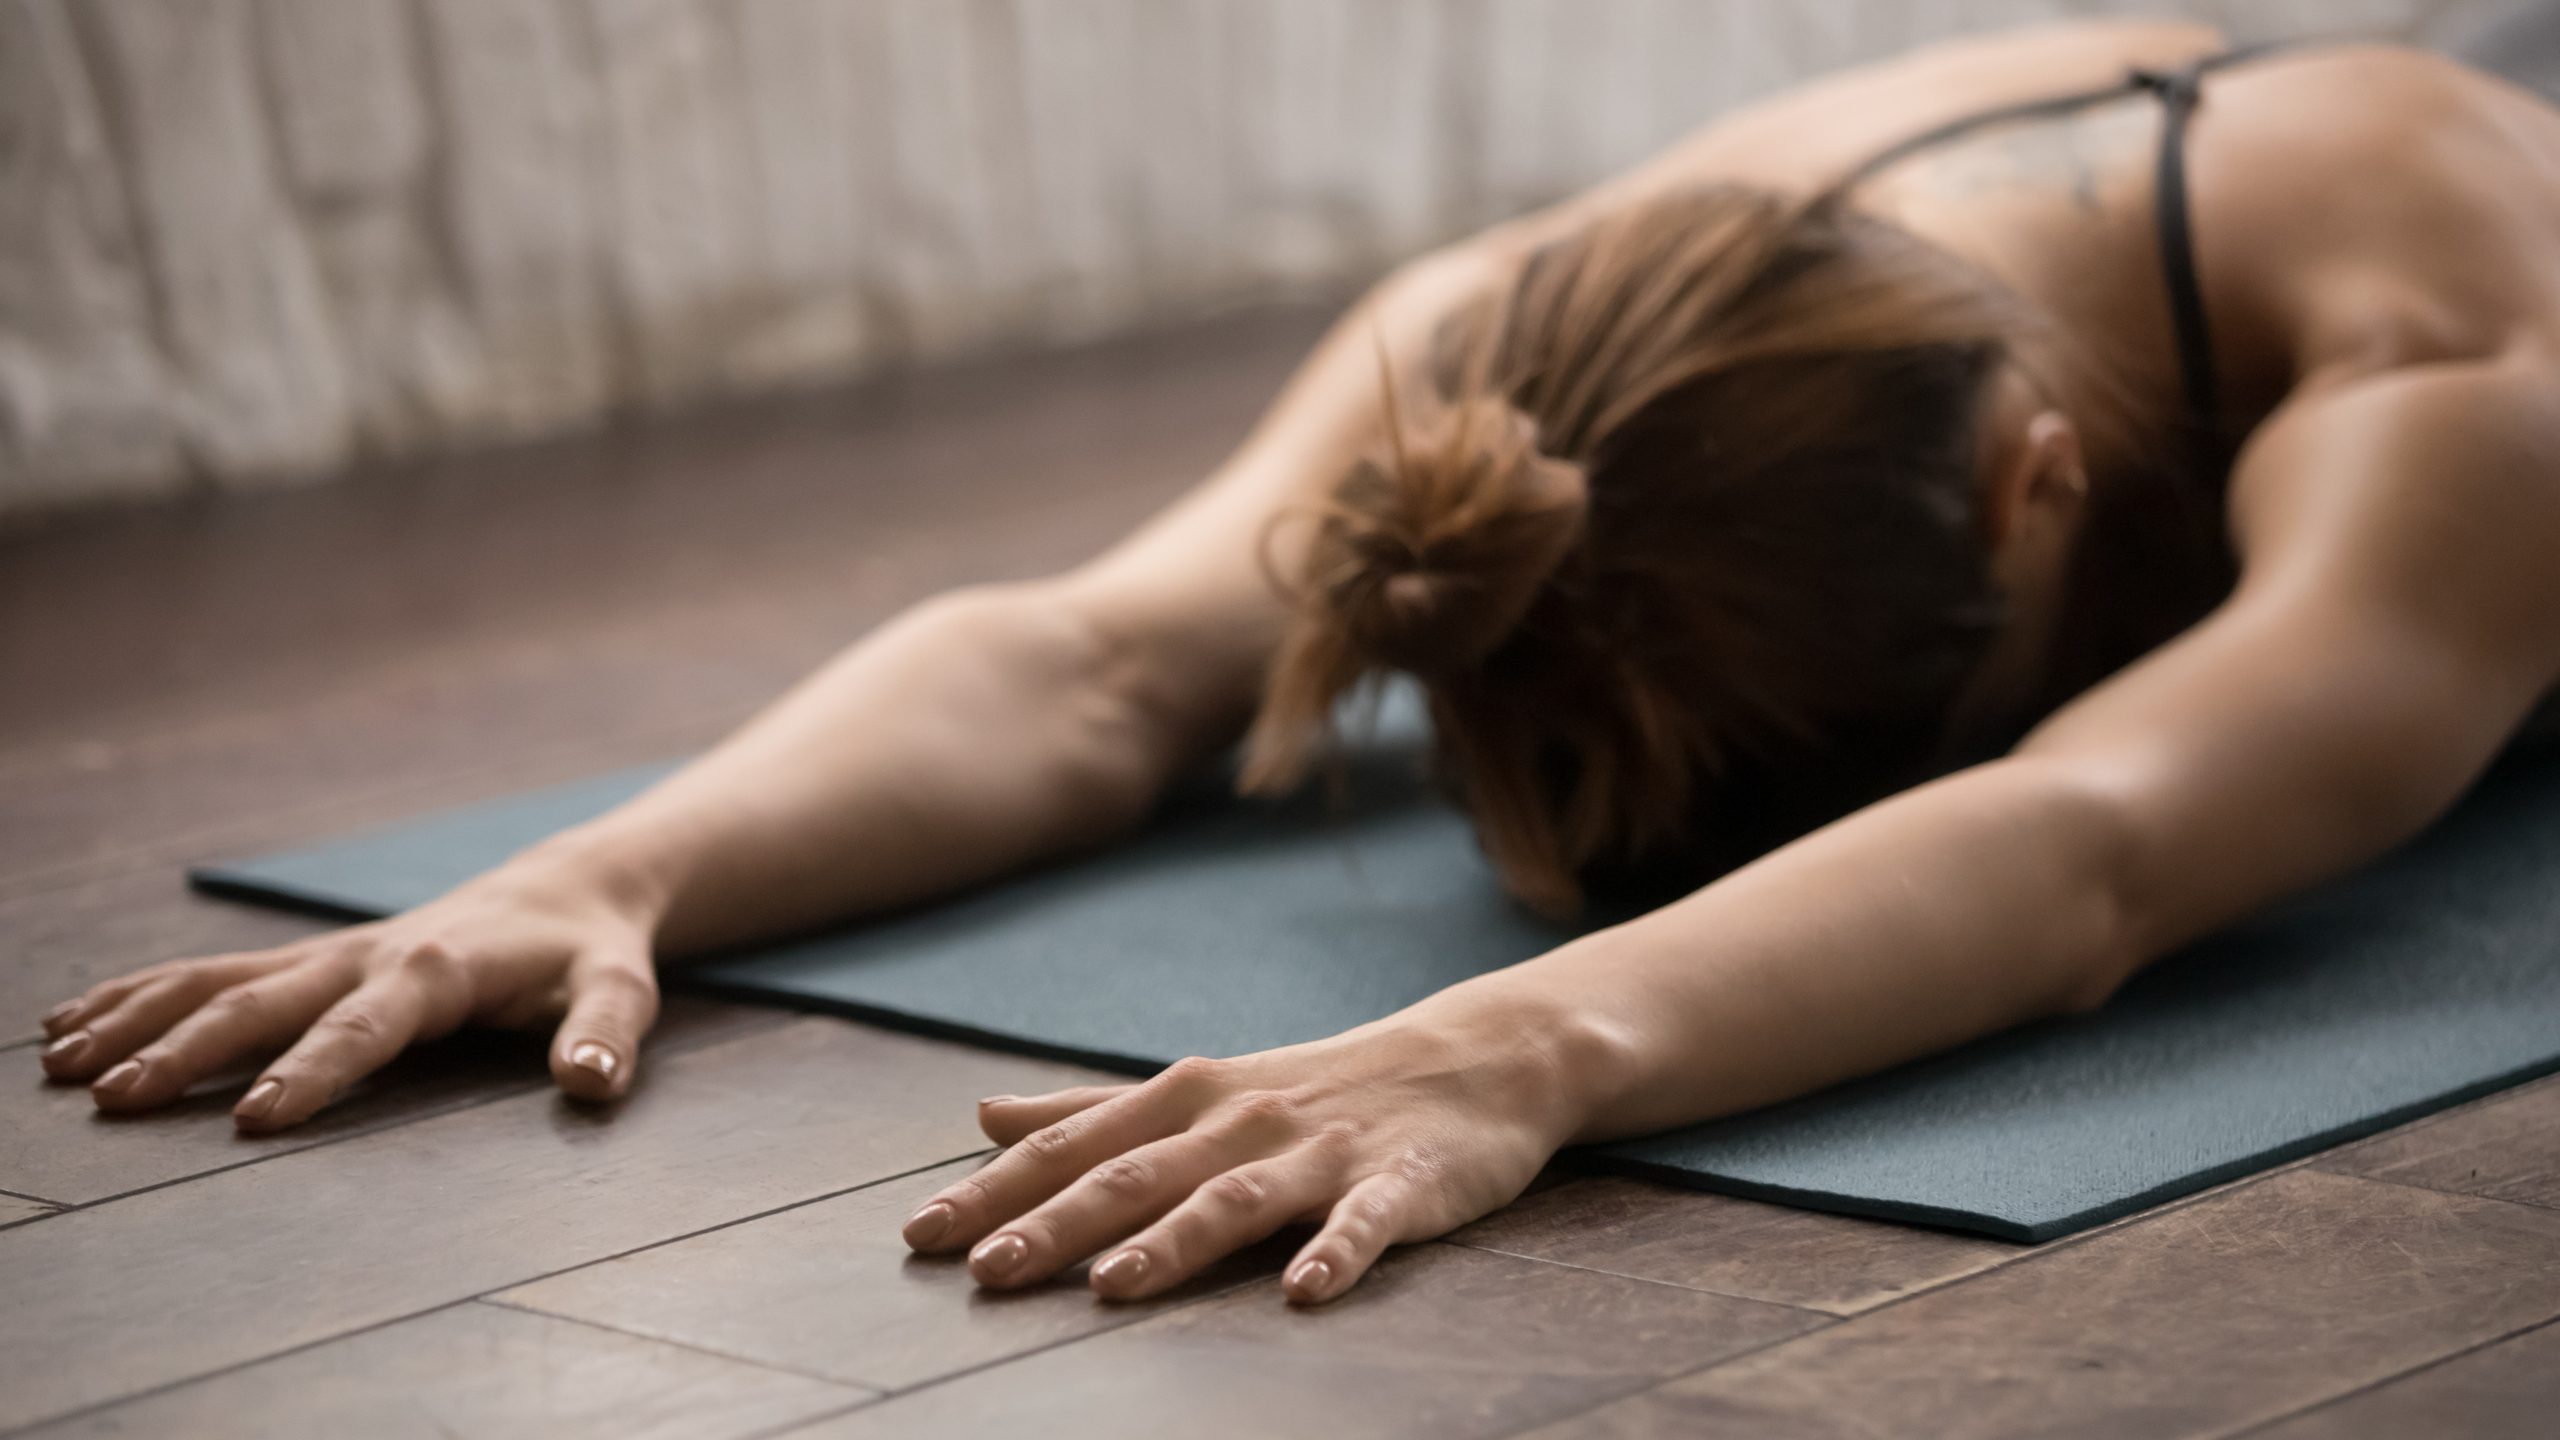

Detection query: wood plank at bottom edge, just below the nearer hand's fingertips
xmin=799 ymin=1245 xmax=1828 ymax=1440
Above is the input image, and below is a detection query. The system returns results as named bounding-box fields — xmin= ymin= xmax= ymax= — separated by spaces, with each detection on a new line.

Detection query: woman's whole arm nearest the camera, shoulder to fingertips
xmin=906 ymin=359 xmax=2560 ymax=1302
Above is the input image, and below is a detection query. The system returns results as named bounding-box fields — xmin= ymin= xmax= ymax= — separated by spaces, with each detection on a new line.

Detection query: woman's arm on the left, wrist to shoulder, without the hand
xmin=509 ymin=246 xmax=1503 ymax=953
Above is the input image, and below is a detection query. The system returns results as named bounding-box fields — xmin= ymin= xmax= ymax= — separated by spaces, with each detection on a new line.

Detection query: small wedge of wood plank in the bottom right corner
xmin=2250 ymin=1325 xmax=2560 ymax=1440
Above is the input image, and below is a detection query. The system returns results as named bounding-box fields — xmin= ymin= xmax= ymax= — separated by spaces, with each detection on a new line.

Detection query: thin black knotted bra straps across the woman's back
xmin=1838 ymin=41 xmax=2286 ymax=446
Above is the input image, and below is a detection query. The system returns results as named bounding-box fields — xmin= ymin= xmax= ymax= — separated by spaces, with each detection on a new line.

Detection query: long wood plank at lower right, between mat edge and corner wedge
xmin=1539 ymin=1168 xmax=2560 ymax=1440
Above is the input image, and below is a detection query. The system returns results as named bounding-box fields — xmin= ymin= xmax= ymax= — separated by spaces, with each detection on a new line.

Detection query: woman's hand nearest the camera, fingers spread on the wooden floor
xmin=906 ymin=992 xmax=1580 ymax=1304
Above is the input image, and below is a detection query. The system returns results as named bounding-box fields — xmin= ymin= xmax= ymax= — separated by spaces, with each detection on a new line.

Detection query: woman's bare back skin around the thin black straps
xmin=1521 ymin=23 xmax=2560 ymax=476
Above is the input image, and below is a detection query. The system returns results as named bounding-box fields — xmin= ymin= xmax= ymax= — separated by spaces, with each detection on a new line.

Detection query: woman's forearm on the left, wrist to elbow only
xmin=522 ymin=584 xmax=1162 ymax=956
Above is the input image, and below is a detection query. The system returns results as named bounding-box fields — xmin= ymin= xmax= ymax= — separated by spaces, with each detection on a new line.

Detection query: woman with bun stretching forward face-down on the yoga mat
xmin=44 ymin=23 xmax=2560 ymax=1302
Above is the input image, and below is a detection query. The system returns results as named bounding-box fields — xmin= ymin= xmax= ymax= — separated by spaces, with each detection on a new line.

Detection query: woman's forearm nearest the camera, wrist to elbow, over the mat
xmin=1423 ymin=761 xmax=2150 ymax=1140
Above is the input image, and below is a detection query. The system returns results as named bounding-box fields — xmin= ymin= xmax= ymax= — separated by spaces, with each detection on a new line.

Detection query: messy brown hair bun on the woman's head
xmin=1311 ymin=395 xmax=1590 ymax=676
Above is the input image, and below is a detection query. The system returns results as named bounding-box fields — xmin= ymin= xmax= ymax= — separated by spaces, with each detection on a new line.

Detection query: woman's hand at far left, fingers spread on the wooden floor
xmin=44 ymin=851 xmax=658 ymax=1133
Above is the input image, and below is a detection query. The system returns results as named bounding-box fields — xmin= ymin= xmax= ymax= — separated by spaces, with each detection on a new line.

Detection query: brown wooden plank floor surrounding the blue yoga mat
xmin=0 ymin=304 xmax=2560 ymax=1440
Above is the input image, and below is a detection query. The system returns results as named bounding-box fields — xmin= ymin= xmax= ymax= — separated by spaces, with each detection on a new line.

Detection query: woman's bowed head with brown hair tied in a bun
xmin=1244 ymin=187 xmax=2071 ymax=907
